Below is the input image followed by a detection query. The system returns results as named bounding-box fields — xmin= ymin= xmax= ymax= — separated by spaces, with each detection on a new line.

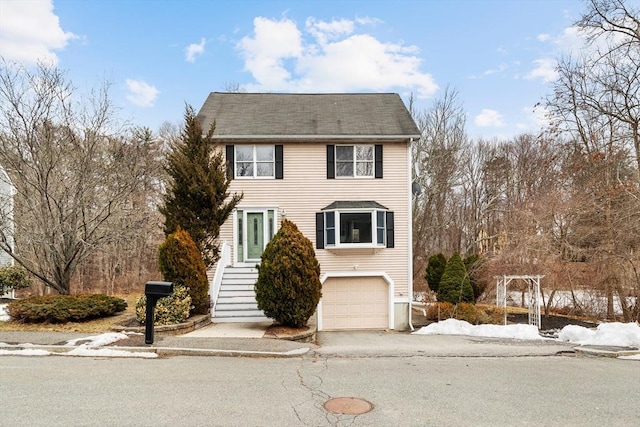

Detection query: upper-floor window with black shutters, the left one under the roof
xmin=226 ymin=145 xmax=283 ymax=179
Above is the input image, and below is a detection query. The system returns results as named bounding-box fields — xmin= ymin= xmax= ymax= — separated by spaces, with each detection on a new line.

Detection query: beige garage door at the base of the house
xmin=322 ymin=277 xmax=389 ymax=330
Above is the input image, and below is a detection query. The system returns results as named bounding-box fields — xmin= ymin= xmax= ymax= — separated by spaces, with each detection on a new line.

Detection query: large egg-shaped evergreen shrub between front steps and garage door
xmin=255 ymin=219 xmax=322 ymax=327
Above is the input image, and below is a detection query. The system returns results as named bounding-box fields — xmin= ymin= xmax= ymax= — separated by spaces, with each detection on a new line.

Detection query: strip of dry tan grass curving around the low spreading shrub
xmin=0 ymin=294 xmax=140 ymax=333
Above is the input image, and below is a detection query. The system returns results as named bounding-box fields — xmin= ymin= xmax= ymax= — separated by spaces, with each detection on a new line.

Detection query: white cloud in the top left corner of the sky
xmin=0 ymin=0 xmax=76 ymax=65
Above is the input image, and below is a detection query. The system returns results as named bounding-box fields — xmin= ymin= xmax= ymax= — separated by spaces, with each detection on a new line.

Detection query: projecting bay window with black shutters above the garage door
xmin=316 ymin=202 xmax=395 ymax=249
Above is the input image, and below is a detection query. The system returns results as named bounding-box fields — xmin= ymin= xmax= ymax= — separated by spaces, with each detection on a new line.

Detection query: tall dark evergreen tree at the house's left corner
xmin=160 ymin=105 xmax=242 ymax=268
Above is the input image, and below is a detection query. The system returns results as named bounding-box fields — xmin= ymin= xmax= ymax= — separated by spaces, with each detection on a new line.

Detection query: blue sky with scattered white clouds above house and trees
xmin=0 ymin=0 xmax=616 ymax=138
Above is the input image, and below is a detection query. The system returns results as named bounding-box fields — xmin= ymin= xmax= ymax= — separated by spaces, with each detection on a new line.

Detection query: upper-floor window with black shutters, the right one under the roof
xmin=327 ymin=144 xmax=382 ymax=179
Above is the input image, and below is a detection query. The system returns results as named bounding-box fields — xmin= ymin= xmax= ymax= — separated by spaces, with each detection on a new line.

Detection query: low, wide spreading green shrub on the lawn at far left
xmin=7 ymin=294 xmax=127 ymax=323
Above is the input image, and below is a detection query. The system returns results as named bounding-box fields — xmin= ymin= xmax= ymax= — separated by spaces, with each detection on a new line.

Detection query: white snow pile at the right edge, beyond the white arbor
xmin=558 ymin=322 xmax=640 ymax=348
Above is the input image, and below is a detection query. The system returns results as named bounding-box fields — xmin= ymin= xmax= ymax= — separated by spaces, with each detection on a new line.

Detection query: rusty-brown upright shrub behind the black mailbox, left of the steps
xmin=158 ymin=227 xmax=210 ymax=314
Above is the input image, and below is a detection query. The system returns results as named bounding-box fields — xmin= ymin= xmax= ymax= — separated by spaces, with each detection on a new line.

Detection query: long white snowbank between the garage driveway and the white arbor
xmin=413 ymin=319 xmax=543 ymax=340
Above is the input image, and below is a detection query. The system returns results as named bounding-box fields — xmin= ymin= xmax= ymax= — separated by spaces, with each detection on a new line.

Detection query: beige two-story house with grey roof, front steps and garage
xmin=198 ymin=93 xmax=420 ymax=330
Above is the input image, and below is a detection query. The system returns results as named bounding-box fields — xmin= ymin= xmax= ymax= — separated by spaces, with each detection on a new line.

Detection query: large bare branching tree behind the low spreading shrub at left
xmin=0 ymin=62 xmax=160 ymax=294
